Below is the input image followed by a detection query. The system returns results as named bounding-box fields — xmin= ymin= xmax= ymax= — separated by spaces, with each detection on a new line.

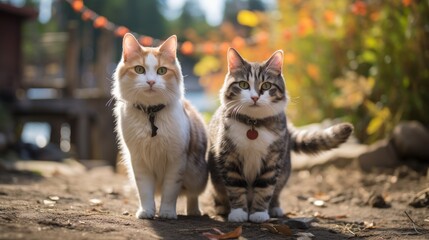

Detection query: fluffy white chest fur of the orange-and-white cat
xmin=118 ymin=101 xmax=189 ymax=178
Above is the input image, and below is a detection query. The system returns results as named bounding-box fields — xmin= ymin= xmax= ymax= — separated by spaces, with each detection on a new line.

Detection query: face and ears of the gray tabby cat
xmin=221 ymin=48 xmax=287 ymax=118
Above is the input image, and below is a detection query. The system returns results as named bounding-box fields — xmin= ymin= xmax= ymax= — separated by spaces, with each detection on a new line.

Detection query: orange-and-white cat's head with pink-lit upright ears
xmin=115 ymin=34 xmax=183 ymax=105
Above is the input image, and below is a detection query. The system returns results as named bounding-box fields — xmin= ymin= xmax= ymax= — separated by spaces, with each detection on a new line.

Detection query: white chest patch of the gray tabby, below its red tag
xmin=228 ymin=120 xmax=276 ymax=182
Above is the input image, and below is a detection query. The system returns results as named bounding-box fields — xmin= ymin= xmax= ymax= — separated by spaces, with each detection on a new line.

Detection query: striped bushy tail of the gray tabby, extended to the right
xmin=288 ymin=123 xmax=353 ymax=154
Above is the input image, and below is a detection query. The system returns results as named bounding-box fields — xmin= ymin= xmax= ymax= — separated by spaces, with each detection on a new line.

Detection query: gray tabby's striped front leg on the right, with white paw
xmin=249 ymin=173 xmax=276 ymax=223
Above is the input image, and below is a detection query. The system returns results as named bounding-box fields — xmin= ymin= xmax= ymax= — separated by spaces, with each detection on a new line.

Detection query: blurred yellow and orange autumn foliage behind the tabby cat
xmin=197 ymin=0 xmax=429 ymax=142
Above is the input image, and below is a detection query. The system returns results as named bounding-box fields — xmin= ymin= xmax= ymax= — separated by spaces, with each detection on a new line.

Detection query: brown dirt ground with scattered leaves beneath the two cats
xmin=0 ymin=158 xmax=429 ymax=239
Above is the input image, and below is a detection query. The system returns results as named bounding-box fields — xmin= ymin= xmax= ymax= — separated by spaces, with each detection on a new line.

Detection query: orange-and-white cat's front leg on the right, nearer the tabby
xmin=159 ymin=157 xmax=185 ymax=219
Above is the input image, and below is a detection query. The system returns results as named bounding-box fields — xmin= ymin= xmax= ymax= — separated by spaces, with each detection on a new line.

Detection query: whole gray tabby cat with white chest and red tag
xmin=208 ymin=48 xmax=353 ymax=222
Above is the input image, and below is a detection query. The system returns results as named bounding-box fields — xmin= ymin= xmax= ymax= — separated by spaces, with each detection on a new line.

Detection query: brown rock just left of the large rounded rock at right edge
xmin=358 ymin=140 xmax=400 ymax=171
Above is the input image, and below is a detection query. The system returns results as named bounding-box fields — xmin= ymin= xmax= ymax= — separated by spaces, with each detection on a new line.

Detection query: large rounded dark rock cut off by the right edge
xmin=392 ymin=121 xmax=429 ymax=162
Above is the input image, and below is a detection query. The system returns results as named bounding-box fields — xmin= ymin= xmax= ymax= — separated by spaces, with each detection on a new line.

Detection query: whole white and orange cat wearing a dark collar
xmin=112 ymin=34 xmax=207 ymax=219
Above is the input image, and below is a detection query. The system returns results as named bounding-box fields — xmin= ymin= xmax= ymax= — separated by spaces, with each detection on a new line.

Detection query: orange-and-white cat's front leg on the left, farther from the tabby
xmin=134 ymin=170 xmax=155 ymax=219
